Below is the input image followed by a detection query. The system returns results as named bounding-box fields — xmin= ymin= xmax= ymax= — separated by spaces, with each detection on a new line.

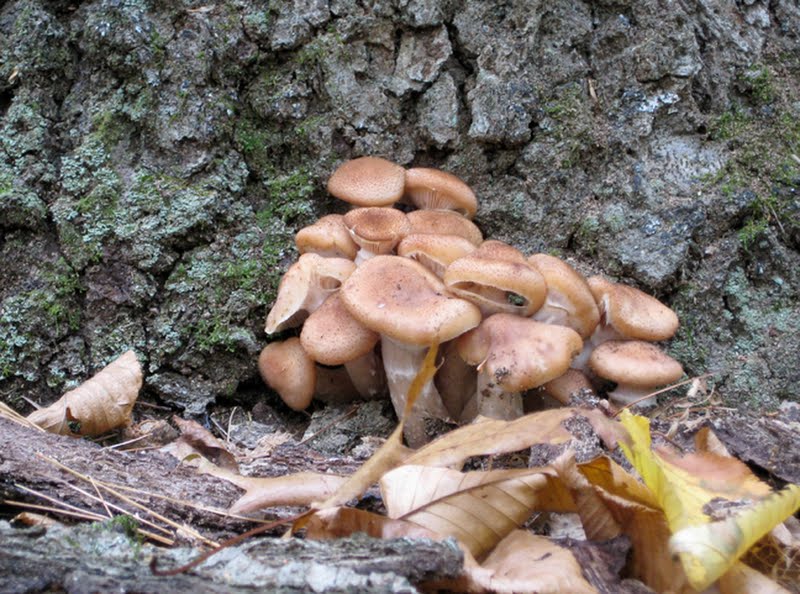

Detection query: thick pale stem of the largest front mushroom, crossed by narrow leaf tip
xmin=381 ymin=335 xmax=450 ymax=447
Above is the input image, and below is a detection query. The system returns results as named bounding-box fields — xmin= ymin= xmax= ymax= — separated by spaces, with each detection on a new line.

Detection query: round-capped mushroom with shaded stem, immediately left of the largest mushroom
xmin=300 ymin=293 xmax=386 ymax=399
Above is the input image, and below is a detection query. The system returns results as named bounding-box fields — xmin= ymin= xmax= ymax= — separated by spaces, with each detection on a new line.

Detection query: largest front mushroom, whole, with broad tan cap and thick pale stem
xmin=341 ymin=256 xmax=481 ymax=447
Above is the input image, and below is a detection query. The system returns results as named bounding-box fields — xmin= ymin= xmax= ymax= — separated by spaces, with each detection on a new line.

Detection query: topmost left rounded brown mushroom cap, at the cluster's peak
xmin=328 ymin=157 xmax=406 ymax=206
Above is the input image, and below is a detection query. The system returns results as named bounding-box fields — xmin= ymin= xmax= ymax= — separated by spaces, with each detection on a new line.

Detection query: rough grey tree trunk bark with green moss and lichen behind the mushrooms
xmin=0 ymin=0 xmax=800 ymax=414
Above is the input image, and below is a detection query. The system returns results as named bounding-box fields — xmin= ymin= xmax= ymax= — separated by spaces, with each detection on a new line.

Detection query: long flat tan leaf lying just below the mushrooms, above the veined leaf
xmin=406 ymin=408 xmax=624 ymax=467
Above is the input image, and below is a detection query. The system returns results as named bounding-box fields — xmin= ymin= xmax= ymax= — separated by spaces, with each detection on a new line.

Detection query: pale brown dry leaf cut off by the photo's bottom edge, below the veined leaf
xmin=471 ymin=530 xmax=597 ymax=594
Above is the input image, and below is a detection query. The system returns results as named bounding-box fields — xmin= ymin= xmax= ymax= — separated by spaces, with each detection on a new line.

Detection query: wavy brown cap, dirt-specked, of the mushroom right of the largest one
xmin=457 ymin=313 xmax=583 ymax=392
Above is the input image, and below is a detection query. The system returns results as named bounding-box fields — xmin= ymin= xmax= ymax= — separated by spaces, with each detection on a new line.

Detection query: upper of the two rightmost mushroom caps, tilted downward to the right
xmin=587 ymin=276 xmax=679 ymax=341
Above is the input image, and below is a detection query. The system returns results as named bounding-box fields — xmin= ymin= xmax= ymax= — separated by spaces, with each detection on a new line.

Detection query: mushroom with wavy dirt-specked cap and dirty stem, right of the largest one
xmin=457 ymin=313 xmax=583 ymax=420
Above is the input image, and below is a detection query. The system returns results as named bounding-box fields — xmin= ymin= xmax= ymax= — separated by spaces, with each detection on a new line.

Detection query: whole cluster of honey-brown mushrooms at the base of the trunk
xmin=259 ymin=157 xmax=683 ymax=447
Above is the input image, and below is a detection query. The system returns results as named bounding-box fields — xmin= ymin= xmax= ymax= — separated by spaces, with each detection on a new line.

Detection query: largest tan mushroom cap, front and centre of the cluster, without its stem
xmin=341 ymin=256 xmax=481 ymax=346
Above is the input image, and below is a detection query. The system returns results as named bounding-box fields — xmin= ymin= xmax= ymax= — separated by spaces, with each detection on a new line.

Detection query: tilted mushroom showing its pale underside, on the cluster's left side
xmin=264 ymin=254 xmax=356 ymax=334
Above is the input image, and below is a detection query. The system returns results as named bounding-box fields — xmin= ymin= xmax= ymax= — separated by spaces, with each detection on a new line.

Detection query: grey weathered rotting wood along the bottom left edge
xmin=0 ymin=521 xmax=462 ymax=594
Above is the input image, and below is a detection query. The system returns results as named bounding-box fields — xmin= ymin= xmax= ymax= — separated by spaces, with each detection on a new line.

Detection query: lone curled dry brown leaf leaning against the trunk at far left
xmin=28 ymin=351 xmax=142 ymax=437
